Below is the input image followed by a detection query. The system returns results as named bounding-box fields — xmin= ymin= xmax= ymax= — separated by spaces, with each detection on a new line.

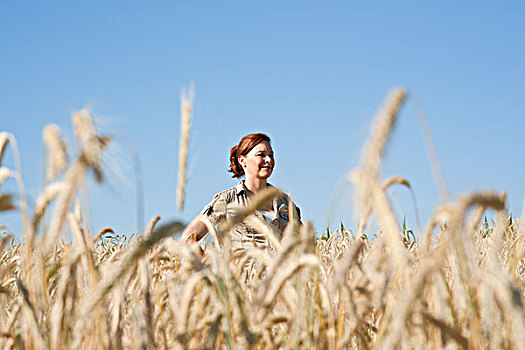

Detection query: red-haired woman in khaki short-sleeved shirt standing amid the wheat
xmin=181 ymin=133 xmax=301 ymax=252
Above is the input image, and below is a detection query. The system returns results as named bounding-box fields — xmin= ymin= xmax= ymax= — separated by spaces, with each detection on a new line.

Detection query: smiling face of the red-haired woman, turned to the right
xmin=239 ymin=141 xmax=275 ymax=179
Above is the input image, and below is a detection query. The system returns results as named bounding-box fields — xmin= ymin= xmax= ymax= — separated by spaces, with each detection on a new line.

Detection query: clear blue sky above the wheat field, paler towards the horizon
xmin=0 ymin=1 xmax=525 ymax=238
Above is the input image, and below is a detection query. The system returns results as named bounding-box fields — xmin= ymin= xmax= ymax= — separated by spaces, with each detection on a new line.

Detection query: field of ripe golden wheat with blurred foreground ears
xmin=0 ymin=89 xmax=525 ymax=349
